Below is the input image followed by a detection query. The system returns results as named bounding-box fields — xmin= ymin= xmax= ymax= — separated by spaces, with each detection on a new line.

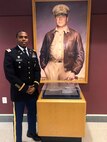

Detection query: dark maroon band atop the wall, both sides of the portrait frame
xmin=0 ymin=0 xmax=107 ymax=16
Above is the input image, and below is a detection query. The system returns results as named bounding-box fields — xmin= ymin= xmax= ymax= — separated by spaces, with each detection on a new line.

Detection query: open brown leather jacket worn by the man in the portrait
xmin=40 ymin=28 xmax=84 ymax=74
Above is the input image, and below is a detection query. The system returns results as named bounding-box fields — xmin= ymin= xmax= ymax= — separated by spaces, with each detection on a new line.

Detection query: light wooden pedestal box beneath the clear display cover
xmin=37 ymin=92 xmax=86 ymax=138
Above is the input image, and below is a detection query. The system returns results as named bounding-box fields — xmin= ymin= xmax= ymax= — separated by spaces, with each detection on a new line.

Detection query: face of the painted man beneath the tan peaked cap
xmin=55 ymin=15 xmax=68 ymax=28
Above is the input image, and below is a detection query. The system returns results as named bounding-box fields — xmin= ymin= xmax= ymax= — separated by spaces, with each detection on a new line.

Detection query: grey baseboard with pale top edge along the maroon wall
xmin=0 ymin=114 xmax=107 ymax=122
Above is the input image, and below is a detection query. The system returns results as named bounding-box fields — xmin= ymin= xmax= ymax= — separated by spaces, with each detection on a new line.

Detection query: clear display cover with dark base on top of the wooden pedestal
xmin=42 ymin=83 xmax=81 ymax=99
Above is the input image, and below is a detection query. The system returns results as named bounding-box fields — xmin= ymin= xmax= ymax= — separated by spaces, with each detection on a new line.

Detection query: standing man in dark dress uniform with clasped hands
xmin=4 ymin=31 xmax=40 ymax=142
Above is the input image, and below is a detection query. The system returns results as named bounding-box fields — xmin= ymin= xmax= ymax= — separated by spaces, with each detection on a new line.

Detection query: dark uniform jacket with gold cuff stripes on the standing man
xmin=4 ymin=46 xmax=40 ymax=101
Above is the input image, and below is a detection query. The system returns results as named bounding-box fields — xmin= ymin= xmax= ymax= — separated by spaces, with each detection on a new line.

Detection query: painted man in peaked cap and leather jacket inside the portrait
xmin=40 ymin=4 xmax=84 ymax=80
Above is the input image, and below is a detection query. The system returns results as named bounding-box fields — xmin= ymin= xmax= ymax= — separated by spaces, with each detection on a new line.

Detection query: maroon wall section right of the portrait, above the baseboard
xmin=81 ymin=15 xmax=107 ymax=114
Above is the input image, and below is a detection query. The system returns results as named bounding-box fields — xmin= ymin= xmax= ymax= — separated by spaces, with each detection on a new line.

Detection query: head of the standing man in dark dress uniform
xmin=17 ymin=32 xmax=28 ymax=47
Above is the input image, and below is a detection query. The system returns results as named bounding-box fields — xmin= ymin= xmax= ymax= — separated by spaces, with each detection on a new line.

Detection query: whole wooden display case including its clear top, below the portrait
xmin=37 ymin=83 xmax=86 ymax=138
